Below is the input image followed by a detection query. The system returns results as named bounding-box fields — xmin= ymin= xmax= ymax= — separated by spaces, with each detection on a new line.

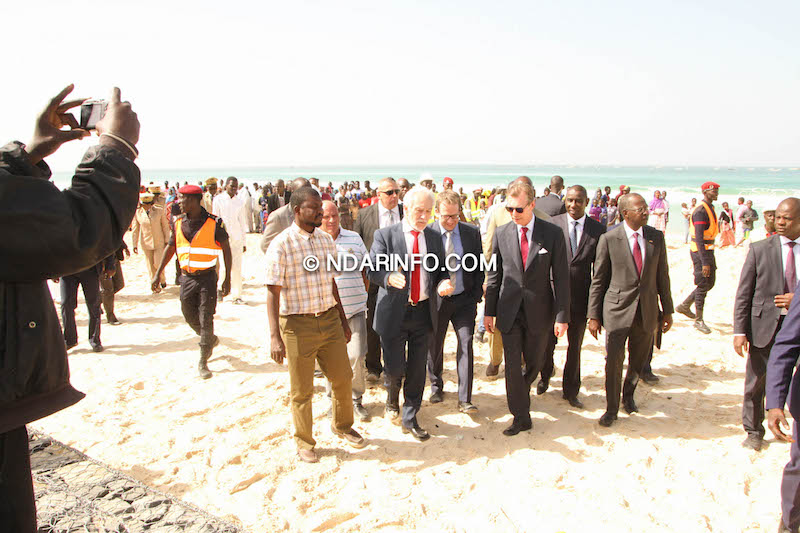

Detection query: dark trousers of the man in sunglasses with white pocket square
xmin=502 ymin=308 xmax=553 ymax=423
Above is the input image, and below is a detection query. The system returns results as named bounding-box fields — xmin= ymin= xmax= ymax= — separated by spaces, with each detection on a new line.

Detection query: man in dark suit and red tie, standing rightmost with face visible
xmin=733 ymin=198 xmax=800 ymax=451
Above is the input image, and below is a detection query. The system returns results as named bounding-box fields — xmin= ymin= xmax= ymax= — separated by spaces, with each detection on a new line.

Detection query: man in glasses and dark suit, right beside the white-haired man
xmin=428 ymin=190 xmax=484 ymax=414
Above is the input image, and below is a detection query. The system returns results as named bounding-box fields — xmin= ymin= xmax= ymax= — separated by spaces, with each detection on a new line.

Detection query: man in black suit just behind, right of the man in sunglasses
xmin=536 ymin=185 xmax=606 ymax=409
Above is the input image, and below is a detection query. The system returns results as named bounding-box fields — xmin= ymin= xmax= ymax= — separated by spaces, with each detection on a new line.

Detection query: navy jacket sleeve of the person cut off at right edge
xmin=766 ymin=284 xmax=800 ymax=409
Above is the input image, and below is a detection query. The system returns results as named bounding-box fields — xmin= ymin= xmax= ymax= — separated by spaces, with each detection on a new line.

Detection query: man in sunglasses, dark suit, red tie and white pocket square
xmin=484 ymin=181 xmax=569 ymax=436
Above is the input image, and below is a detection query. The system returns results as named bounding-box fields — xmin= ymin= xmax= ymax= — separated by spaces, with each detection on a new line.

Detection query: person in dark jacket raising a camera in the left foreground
xmin=0 ymin=85 xmax=140 ymax=533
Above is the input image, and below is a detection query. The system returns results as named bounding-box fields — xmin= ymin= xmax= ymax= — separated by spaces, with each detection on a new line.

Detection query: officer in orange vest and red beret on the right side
xmin=675 ymin=181 xmax=719 ymax=335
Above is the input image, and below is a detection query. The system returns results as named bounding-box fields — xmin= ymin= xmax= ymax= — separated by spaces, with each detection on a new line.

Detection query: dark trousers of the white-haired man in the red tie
xmin=380 ymin=300 xmax=432 ymax=428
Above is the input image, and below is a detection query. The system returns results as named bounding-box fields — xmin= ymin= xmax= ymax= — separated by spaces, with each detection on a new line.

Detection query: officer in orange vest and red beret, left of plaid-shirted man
xmin=150 ymin=185 xmax=232 ymax=379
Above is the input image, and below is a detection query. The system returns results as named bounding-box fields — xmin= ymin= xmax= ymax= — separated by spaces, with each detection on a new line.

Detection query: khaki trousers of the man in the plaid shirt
xmin=280 ymin=307 xmax=353 ymax=450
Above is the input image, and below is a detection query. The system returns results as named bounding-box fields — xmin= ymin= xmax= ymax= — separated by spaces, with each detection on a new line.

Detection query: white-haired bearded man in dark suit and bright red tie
xmin=369 ymin=182 xmax=453 ymax=442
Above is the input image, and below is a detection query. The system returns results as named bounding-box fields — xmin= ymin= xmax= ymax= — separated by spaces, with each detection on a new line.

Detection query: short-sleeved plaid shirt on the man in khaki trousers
xmin=267 ymin=224 xmax=336 ymax=315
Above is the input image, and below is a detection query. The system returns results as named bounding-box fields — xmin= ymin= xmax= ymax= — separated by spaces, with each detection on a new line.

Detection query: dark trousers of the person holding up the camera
xmin=0 ymin=426 xmax=36 ymax=533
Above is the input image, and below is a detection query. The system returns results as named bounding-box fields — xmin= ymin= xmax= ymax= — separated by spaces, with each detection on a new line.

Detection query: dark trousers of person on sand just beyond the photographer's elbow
xmin=59 ymin=267 xmax=100 ymax=346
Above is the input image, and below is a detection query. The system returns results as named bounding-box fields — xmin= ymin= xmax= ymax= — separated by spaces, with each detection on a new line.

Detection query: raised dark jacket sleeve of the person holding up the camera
xmin=0 ymin=143 xmax=140 ymax=282
